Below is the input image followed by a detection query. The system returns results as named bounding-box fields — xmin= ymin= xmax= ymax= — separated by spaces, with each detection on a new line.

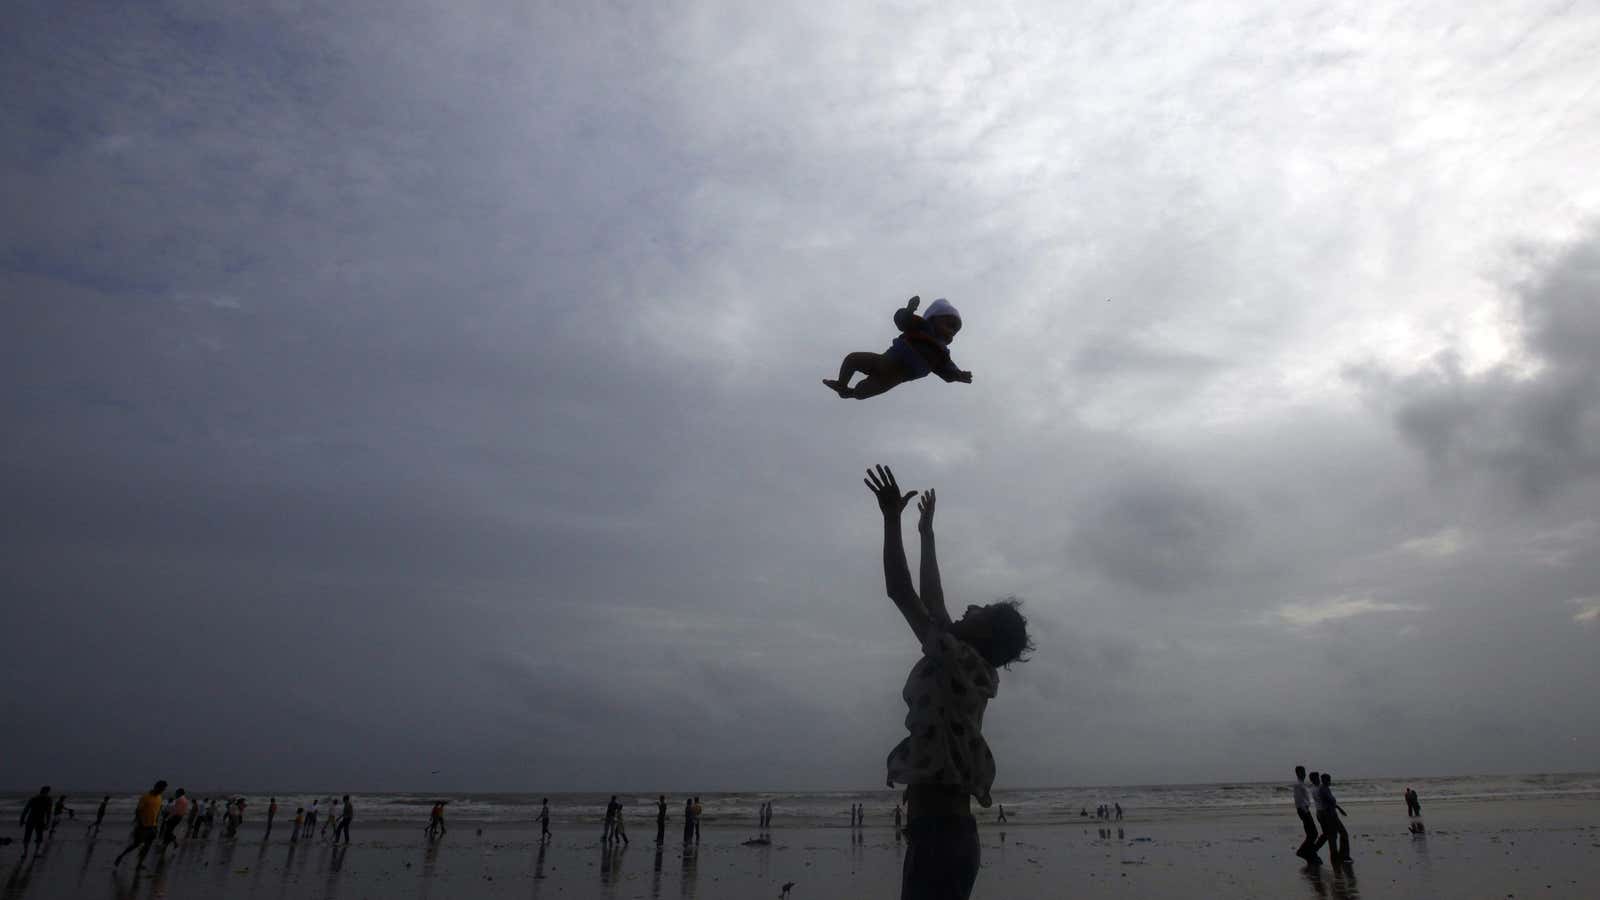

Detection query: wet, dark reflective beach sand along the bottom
xmin=0 ymin=799 xmax=1600 ymax=900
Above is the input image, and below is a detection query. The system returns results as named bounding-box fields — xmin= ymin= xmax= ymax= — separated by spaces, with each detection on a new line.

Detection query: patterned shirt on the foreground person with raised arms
xmin=888 ymin=626 xmax=1000 ymax=807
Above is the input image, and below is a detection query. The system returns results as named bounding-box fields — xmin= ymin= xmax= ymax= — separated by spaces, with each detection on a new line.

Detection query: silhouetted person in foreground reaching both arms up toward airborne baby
xmin=864 ymin=466 xmax=1032 ymax=900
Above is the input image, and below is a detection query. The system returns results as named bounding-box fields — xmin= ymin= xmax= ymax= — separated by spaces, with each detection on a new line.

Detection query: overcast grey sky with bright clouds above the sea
xmin=0 ymin=0 xmax=1600 ymax=791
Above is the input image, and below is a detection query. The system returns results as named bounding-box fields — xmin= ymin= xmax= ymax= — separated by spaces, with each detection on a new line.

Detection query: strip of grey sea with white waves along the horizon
xmin=15 ymin=773 xmax=1600 ymax=830
